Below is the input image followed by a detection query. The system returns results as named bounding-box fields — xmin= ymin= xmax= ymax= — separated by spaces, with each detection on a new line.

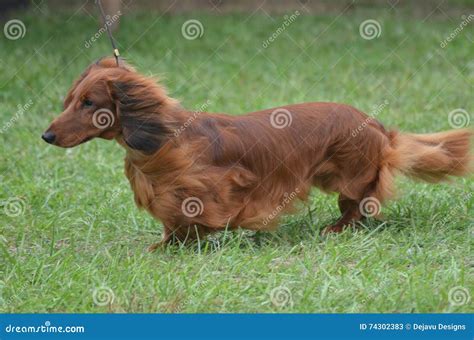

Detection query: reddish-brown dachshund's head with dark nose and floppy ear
xmin=42 ymin=58 xmax=177 ymax=153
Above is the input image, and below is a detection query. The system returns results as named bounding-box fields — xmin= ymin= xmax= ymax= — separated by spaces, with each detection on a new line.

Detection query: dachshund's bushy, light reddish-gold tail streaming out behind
xmin=385 ymin=129 xmax=473 ymax=182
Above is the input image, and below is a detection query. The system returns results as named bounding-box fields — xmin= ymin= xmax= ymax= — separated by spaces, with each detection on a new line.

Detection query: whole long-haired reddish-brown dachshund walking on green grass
xmin=42 ymin=58 xmax=472 ymax=249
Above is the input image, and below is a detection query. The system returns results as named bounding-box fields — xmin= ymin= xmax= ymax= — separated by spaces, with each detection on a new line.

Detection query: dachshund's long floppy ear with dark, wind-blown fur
xmin=109 ymin=80 xmax=170 ymax=154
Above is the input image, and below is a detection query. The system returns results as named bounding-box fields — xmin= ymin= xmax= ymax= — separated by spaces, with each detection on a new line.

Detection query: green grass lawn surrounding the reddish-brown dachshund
xmin=0 ymin=4 xmax=474 ymax=313
